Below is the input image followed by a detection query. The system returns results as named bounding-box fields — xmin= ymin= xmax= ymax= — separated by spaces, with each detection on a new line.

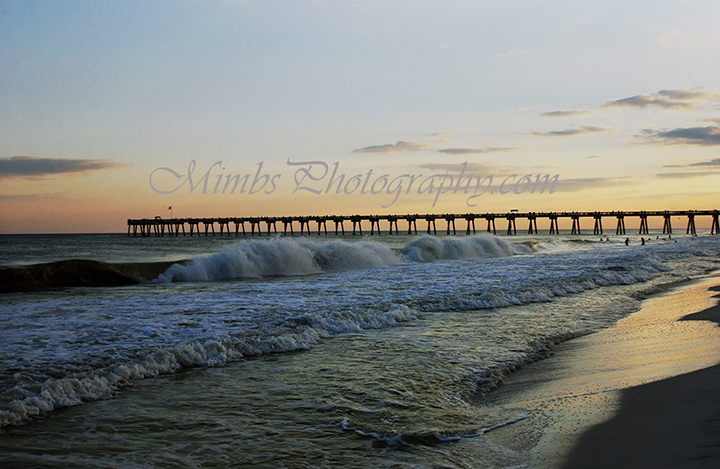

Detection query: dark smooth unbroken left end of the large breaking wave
xmin=0 ymin=259 xmax=180 ymax=293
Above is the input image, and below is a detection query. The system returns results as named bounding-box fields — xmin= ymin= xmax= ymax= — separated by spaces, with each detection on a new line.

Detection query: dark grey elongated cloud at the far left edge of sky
xmin=0 ymin=156 xmax=127 ymax=179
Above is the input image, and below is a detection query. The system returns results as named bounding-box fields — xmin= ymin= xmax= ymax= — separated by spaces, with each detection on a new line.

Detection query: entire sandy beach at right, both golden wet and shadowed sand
xmin=487 ymin=276 xmax=720 ymax=468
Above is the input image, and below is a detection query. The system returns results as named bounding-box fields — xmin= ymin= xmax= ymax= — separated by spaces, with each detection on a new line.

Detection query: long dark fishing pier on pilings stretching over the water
xmin=127 ymin=209 xmax=720 ymax=236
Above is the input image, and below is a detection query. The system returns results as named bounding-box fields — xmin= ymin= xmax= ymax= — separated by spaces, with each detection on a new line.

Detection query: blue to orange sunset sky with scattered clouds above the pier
xmin=0 ymin=0 xmax=720 ymax=233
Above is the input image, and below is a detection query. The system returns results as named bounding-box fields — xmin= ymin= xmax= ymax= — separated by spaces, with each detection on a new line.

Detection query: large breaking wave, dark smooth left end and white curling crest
xmin=0 ymin=235 xmax=534 ymax=293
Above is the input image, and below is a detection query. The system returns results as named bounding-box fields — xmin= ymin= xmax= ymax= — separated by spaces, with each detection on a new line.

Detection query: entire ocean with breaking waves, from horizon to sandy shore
xmin=0 ymin=232 xmax=720 ymax=468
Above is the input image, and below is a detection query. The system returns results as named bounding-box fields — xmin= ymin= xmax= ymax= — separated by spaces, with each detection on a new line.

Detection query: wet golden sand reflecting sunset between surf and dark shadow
xmin=491 ymin=277 xmax=720 ymax=467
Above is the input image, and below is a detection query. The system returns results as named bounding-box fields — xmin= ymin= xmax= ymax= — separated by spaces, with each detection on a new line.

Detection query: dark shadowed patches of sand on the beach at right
xmin=563 ymin=286 xmax=720 ymax=468
